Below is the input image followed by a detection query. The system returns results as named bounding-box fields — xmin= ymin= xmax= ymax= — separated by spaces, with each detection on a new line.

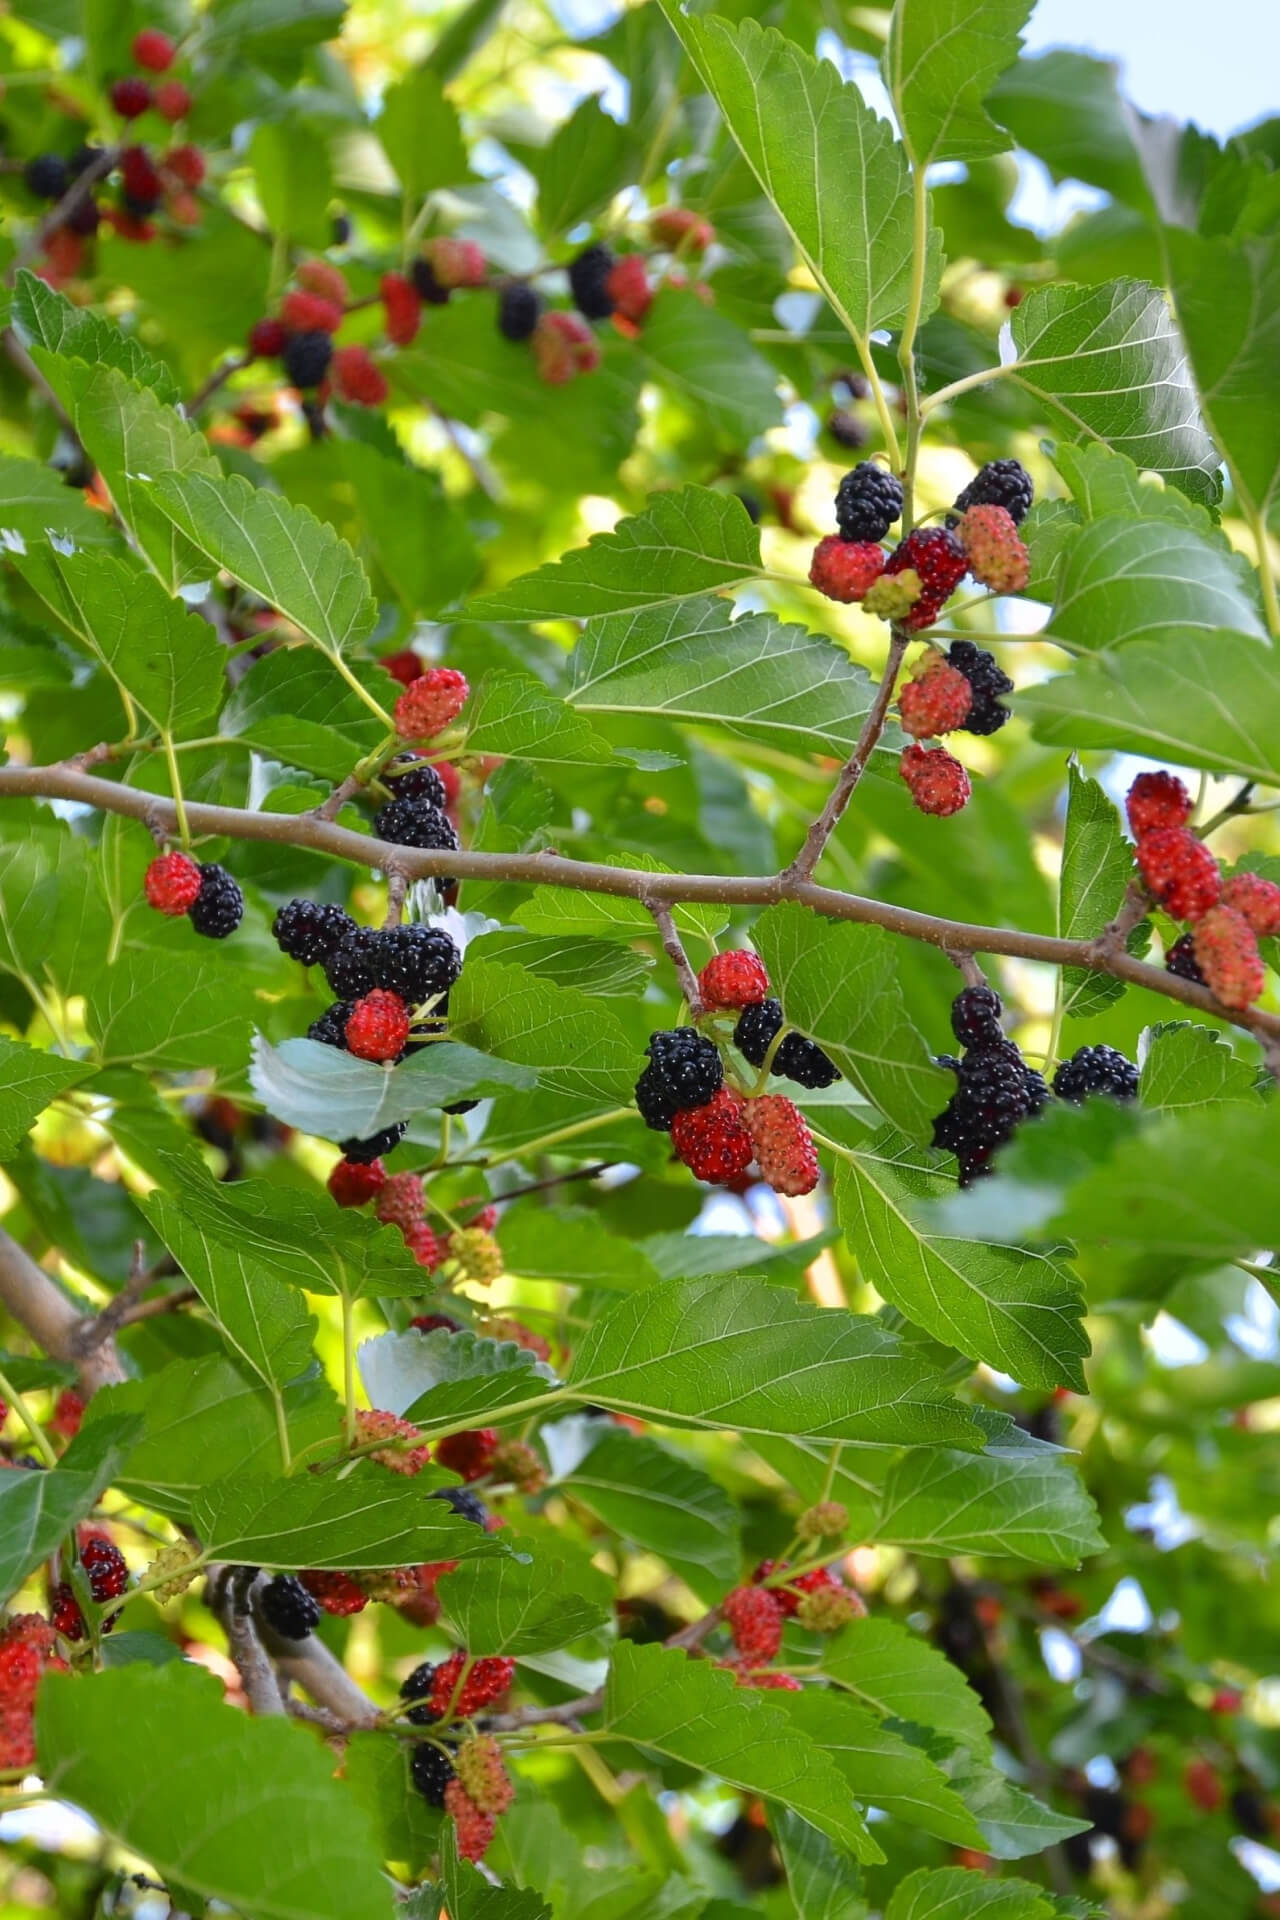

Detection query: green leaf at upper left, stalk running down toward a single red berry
xmin=152 ymin=470 xmax=376 ymax=655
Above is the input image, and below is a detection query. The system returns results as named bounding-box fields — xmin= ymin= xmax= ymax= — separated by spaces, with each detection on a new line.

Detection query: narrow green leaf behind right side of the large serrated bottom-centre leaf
xmin=783 ymin=1688 xmax=983 ymax=1847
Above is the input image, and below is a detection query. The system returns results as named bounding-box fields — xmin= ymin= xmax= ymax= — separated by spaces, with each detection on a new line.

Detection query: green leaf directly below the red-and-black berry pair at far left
xmin=84 ymin=947 xmax=255 ymax=1071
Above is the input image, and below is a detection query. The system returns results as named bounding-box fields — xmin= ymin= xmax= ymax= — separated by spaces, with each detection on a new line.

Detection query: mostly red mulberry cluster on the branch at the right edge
xmin=1125 ymin=772 xmax=1280 ymax=1012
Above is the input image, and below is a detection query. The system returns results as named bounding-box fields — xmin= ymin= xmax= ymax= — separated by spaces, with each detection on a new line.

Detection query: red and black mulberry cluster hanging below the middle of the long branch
xmin=635 ymin=948 xmax=841 ymax=1194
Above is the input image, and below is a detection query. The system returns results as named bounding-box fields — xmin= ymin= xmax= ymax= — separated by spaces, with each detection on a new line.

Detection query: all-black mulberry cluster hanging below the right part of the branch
xmin=933 ymin=987 xmax=1138 ymax=1187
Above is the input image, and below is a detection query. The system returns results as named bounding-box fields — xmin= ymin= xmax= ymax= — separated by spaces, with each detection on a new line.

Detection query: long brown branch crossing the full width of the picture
xmin=0 ymin=764 xmax=1280 ymax=1054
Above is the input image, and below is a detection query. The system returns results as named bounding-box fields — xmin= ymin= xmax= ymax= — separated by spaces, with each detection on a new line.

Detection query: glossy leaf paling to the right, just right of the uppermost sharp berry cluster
xmin=1046 ymin=515 xmax=1265 ymax=653
